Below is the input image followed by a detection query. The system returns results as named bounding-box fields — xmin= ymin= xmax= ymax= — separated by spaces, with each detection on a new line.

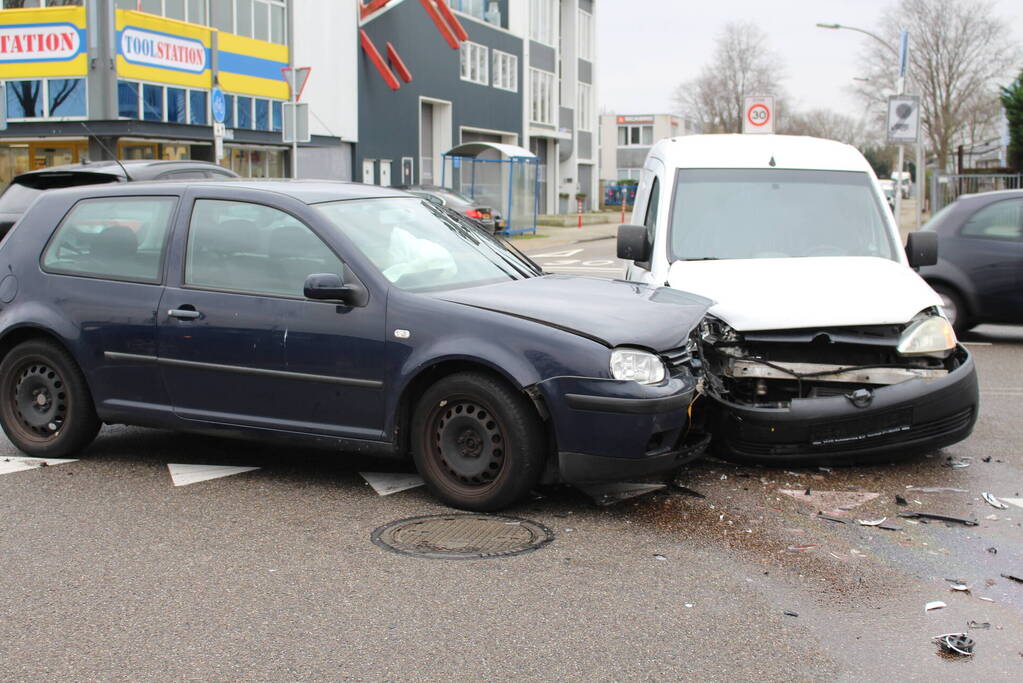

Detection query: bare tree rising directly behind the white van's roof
xmin=673 ymin=21 xmax=783 ymax=133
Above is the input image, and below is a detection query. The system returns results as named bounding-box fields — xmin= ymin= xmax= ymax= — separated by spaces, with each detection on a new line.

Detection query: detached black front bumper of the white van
xmin=711 ymin=345 xmax=979 ymax=462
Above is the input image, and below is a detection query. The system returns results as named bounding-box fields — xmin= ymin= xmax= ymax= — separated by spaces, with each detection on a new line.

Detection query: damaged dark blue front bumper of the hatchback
xmin=536 ymin=373 xmax=708 ymax=484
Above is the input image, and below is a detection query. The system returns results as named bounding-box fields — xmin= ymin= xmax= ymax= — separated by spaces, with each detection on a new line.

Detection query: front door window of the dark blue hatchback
xmin=185 ymin=199 xmax=342 ymax=297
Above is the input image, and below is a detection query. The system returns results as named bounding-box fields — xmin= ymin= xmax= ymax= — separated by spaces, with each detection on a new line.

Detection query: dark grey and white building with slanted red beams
xmin=355 ymin=0 xmax=597 ymax=213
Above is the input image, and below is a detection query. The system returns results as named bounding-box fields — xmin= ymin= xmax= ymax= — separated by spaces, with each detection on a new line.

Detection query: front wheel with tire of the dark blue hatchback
xmin=411 ymin=372 xmax=546 ymax=512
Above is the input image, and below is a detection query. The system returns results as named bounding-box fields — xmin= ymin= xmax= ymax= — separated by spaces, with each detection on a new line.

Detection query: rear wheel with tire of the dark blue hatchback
xmin=0 ymin=340 xmax=101 ymax=458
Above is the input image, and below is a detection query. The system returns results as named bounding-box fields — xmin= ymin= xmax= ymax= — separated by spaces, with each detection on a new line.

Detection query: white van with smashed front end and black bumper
xmin=618 ymin=135 xmax=978 ymax=462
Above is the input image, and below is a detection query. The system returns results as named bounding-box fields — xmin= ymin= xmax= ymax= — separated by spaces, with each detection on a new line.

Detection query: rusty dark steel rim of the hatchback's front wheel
xmin=427 ymin=399 xmax=506 ymax=491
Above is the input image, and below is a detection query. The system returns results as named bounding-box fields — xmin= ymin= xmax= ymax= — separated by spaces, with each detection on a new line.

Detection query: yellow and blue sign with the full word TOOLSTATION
xmin=115 ymin=9 xmax=213 ymax=88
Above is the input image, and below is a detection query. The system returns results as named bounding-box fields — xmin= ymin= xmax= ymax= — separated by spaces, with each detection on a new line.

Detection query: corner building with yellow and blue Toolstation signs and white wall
xmin=0 ymin=0 xmax=358 ymax=183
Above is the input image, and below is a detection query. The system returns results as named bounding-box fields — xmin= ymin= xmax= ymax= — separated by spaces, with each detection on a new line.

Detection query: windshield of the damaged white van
xmin=669 ymin=169 xmax=897 ymax=261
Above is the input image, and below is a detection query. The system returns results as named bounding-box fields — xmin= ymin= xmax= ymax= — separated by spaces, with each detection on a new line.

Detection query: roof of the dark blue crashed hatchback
xmin=43 ymin=178 xmax=411 ymax=203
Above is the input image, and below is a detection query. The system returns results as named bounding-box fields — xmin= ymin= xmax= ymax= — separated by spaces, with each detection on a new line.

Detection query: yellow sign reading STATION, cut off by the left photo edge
xmin=0 ymin=6 xmax=88 ymax=79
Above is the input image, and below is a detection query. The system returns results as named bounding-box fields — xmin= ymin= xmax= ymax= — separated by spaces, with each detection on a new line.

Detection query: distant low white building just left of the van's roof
xmin=601 ymin=113 xmax=693 ymax=182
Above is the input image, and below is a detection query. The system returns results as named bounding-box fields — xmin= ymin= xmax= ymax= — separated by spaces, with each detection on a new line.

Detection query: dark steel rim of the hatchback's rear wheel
xmin=8 ymin=361 xmax=70 ymax=441
